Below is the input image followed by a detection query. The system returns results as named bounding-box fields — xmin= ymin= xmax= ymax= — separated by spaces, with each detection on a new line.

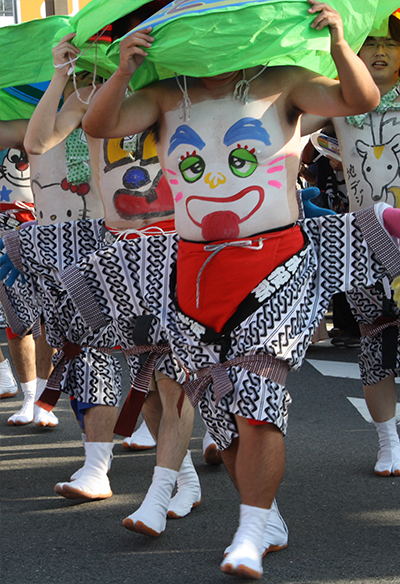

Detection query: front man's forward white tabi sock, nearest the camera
xmin=221 ymin=504 xmax=271 ymax=580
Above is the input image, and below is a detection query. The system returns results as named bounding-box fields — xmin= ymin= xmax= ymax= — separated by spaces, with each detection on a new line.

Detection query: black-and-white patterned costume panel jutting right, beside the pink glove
xmin=304 ymin=206 xmax=400 ymax=295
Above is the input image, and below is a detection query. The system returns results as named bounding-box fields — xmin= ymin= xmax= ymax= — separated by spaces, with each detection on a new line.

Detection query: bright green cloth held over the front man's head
xmin=104 ymin=0 xmax=399 ymax=89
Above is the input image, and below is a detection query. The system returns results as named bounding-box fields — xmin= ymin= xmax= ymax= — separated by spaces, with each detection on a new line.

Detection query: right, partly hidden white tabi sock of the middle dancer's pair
xmin=168 ymin=450 xmax=201 ymax=519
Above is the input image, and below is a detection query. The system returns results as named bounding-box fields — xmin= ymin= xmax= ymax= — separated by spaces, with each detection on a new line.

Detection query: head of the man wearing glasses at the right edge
xmin=358 ymin=15 xmax=400 ymax=93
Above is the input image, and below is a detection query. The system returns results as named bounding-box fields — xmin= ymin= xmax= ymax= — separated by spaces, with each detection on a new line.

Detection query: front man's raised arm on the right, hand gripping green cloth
xmin=291 ymin=0 xmax=380 ymax=118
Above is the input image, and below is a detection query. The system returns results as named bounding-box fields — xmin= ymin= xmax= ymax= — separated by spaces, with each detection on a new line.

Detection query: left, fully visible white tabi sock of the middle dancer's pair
xmin=122 ymin=466 xmax=178 ymax=537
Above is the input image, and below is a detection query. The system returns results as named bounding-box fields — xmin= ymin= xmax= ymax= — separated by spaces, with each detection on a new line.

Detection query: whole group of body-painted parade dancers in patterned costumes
xmin=0 ymin=0 xmax=400 ymax=579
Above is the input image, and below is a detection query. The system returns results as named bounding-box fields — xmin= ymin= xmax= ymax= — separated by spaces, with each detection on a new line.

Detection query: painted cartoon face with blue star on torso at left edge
xmin=0 ymin=148 xmax=33 ymax=205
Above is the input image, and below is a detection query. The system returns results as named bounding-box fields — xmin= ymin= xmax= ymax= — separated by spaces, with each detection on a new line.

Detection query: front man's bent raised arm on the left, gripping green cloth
xmin=83 ymin=27 xmax=160 ymax=138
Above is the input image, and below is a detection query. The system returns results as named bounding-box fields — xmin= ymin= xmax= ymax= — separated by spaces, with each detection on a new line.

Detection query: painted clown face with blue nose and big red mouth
xmin=99 ymin=132 xmax=174 ymax=227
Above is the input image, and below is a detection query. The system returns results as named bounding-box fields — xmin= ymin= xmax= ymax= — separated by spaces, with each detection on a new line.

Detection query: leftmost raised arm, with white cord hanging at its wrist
xmin=24 ymin=33 xmax=87 ymax=154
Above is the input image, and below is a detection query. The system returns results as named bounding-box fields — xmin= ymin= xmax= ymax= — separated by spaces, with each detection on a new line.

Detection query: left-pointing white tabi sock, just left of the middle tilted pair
xmin=54 ymin=442 xmax=114 ymax=499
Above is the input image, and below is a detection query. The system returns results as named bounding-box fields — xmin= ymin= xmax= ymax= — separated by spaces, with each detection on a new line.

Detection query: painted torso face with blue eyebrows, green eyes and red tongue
xmin=163 ymin=100 xmax=296 ymax=241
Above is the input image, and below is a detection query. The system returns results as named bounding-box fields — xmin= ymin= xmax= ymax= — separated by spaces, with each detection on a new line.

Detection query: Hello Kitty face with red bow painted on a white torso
xmin=29 ymin=142 xmax=104 ymax=225
